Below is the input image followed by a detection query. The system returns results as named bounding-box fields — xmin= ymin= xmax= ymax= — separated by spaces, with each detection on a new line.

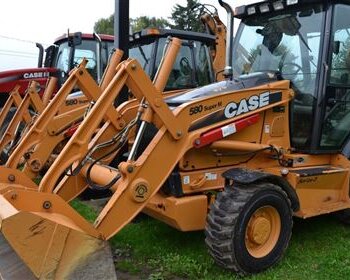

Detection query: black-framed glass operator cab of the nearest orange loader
xmin=233 ymin=0 xmax=350 ymax=156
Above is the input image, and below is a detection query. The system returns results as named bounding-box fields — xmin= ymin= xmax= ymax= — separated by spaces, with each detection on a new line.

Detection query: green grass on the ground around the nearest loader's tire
xmin=73 ymin=202 xmax=350 ymax=280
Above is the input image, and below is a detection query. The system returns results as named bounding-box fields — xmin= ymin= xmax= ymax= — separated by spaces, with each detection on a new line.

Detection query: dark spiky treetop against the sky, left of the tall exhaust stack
xmin=170 ymin=0 xmax=204 ymax=32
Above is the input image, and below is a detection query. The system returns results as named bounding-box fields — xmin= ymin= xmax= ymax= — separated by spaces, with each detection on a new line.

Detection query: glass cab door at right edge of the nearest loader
xmin=319 ymin=4 xmax=350 ymax=151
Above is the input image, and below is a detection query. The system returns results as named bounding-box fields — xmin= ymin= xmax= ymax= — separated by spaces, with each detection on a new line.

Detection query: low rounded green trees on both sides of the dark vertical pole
xmin=94 ymin=15 xmax=170 ymax=35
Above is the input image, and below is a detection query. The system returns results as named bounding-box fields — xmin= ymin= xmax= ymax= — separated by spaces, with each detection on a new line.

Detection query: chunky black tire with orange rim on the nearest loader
xmin=205 ymin=183 xmax=293 ymax=274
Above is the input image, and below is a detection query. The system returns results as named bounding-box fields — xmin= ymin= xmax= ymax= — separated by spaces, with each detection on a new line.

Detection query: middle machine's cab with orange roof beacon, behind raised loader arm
xmin=129 ymin=28 xmax=215 ymax=91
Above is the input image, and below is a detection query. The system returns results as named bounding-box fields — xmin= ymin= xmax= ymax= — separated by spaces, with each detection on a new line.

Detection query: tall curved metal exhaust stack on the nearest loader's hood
xmin=219 ymin=0 xmax=234 ymax=79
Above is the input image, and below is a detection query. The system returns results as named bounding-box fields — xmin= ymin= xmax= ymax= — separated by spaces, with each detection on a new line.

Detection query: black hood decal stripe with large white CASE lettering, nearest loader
xmin=189 ymin=92 xmax=282 ymax=131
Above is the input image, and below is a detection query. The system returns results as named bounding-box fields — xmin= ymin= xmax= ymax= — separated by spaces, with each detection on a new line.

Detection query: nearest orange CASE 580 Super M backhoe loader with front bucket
xmin=0 ymin=0 xmax=350 ymax=279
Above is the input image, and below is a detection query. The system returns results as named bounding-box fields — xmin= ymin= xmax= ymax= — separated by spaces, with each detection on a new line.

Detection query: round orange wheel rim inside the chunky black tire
xmin=245 ymin=206 xmax=281 ymax=258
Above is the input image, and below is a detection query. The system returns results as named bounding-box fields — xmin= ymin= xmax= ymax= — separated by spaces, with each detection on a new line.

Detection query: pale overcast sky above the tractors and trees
xmin=0 ymin=0 xmax=253 ymax=71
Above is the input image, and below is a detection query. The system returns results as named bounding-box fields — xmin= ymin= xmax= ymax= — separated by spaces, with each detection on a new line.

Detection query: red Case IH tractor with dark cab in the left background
xmin=0 ymin=32 xmax=114 ymax=108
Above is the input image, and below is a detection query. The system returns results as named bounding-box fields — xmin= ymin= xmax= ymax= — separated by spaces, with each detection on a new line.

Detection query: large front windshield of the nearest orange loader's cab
xmin=233 ymin=6 xmax=322 ymax=84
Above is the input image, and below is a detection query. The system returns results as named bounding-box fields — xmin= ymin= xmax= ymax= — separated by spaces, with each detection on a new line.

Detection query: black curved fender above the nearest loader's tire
xmin=222 ymin=168 xmax=300 ymax=211
